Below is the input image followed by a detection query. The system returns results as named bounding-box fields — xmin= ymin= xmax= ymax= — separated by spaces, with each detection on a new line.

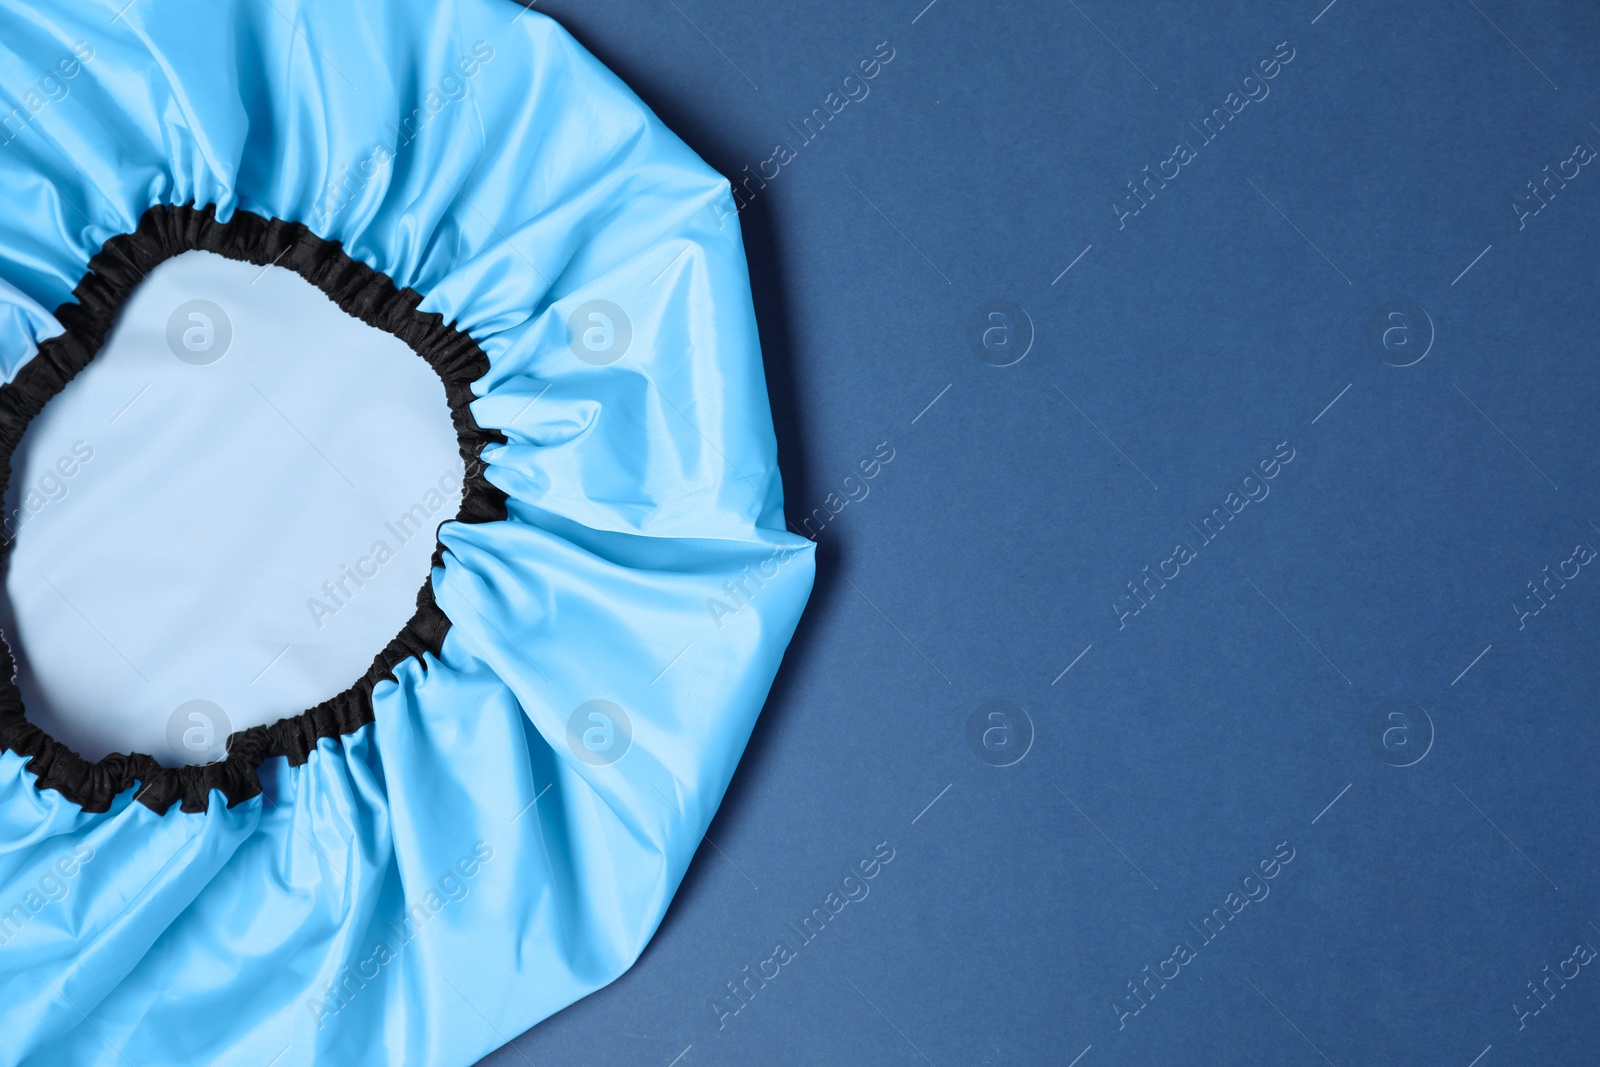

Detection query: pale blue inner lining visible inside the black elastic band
xmin=5 ymin=251 xmax=462 ymax=766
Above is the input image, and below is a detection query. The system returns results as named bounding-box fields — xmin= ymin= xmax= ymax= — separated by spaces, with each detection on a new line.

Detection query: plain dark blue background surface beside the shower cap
xmin=485 ymin=0 xmax=1600 ymax=1067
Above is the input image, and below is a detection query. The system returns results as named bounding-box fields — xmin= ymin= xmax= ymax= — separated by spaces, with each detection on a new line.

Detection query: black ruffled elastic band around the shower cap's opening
xmin=0 ymin=205 xmax=506 ymax=814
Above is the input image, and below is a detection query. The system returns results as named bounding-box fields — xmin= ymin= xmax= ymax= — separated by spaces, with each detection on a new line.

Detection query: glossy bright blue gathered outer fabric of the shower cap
xmin=0 ymin=0 xmax=813 ymax=1067
